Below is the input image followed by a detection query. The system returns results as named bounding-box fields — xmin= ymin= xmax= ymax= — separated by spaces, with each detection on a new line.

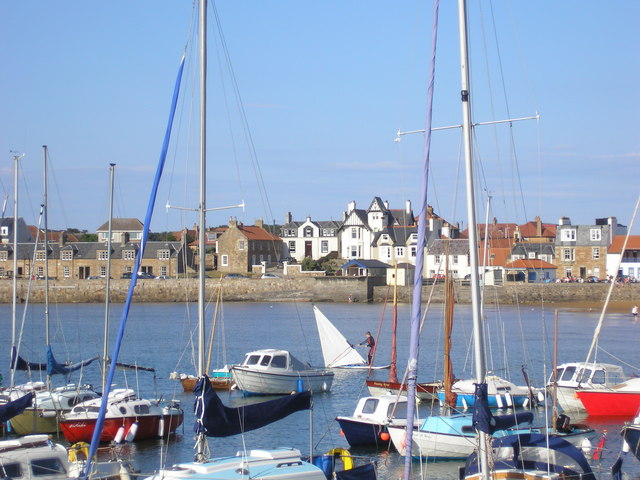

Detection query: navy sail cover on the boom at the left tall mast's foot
xmin=193 ymin=375 xmax=311 ymax=437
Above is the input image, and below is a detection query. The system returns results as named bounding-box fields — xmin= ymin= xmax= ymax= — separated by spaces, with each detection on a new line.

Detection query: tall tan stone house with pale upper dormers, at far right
xmin=555 ymin=217 xmax=627 ymax=279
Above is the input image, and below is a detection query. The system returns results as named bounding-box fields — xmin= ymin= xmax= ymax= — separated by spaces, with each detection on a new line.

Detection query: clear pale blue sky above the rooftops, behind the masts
xmin=0 ymin=0 xmax=640 ymax=234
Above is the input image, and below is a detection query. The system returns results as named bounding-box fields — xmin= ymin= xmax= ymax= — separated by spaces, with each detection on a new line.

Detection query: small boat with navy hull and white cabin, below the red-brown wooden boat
xmin=336 ymin=395 xmax=407 ymax=447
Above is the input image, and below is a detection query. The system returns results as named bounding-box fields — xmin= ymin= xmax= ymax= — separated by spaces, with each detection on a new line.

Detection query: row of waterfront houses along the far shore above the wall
xmin=0 ymin=197 xmax=640 ymax=283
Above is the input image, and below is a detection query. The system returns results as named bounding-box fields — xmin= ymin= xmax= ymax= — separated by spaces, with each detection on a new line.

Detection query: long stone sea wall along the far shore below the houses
xmin=0 ymin=277 xmax=640 ymax=305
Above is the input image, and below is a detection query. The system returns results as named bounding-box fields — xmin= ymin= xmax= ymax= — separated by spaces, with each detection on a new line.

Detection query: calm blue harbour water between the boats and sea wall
xmin=0 ymin=298 xmax=640 ymax=479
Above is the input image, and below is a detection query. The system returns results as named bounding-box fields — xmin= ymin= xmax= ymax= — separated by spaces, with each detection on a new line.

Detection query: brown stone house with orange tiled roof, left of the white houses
xmin=216 ymin=218 xmax=283 ymax=273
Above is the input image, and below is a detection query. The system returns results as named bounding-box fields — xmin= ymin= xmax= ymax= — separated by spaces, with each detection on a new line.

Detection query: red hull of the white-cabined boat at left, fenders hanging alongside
xmin=60 ymin=414 xmax=184 ymax=443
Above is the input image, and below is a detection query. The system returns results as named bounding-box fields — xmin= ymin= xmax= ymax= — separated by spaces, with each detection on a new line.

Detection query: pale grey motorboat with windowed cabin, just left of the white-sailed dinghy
xmin=230 ymin=349 xmax=333 ymax=395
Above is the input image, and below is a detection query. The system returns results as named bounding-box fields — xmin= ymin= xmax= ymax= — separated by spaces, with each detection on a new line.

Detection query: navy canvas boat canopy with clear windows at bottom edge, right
xmin=464 ymin=433 xmax=595 ymax=480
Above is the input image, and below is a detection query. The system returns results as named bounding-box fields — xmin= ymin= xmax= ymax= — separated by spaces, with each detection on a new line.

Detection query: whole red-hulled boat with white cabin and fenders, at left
xmin=60 ymin=389 xmax=184 ymax=443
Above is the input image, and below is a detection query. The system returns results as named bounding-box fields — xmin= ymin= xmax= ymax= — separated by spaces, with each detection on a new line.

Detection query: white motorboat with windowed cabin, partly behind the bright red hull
xmin=547 ymin=362 xmax=626 ymax=412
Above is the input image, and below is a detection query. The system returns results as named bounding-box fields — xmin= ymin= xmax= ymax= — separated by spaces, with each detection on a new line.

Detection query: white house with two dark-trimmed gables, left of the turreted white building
xmin=280 ymin=212 xmax=341 ymax=262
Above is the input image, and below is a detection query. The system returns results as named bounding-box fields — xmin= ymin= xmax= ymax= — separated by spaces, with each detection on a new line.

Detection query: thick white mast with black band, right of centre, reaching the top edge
xmin=458 ymin=0 xmax=489 ymax=479
